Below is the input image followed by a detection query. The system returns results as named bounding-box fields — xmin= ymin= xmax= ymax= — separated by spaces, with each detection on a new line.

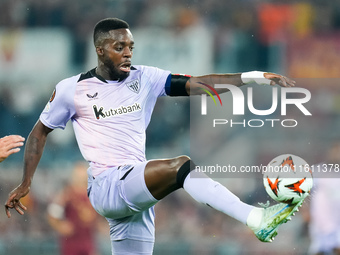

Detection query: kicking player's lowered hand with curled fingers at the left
xmin=5 ymin=184 xmax=30 ymax=218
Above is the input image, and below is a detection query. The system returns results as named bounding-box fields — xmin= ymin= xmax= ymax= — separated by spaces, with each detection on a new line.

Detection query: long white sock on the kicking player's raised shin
xmin=183 ymin=172 xmax=255 ymax=224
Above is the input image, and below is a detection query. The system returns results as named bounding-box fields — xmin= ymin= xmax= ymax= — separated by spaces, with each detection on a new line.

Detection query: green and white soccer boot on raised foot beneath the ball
xmin=247 ymin=200 xmax=303 ymax=242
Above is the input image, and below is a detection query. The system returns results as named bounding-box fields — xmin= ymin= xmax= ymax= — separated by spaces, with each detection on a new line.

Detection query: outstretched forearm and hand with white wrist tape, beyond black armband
xmin=186 ymin=71 xmax=295 ymax=95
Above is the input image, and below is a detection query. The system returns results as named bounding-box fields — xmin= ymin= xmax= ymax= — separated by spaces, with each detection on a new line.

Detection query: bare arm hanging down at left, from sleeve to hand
xmin=5 ymin=121 xmax=52 ymax=218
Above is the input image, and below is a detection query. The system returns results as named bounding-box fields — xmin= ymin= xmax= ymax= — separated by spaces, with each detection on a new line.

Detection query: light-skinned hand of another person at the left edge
xmin=0 ymin=135 xmax=25 ymax=162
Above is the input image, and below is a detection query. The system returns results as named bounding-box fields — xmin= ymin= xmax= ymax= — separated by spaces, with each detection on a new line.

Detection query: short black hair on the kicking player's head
xmin=93 ymin=18 xmax=129 ymax=45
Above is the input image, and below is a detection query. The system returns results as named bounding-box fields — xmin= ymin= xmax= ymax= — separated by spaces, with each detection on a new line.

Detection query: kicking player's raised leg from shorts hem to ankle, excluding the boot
xmin=145 ymin=156 xmax=254 ymax=224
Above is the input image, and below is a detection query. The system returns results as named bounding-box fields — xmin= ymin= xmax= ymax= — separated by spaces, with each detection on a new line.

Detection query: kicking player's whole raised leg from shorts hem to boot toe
xmin=145 ymin=156 xmax=302 ymax=242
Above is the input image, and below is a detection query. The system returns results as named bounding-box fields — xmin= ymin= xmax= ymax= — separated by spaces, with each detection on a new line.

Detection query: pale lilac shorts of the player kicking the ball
xmin=88 ymin=162 xmax=158 ymax=243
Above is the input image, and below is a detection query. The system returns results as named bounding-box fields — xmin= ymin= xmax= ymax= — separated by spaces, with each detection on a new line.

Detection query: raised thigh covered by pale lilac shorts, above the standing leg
xmin=88 ymin=162 xmax=158 ymax=219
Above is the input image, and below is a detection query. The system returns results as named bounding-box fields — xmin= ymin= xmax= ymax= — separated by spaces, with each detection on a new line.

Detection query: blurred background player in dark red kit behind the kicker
xmin=47 ymin=162 xmax=99 ymax=255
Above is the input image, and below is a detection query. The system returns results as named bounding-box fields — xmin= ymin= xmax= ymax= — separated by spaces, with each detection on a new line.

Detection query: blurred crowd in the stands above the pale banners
xmin=0 ymin=0 xmax=340 ymax=69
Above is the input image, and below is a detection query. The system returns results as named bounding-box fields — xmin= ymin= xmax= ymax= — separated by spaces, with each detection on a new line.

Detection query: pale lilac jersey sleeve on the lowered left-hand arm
xmin=40 ymin=77 xmax=77 ymax=129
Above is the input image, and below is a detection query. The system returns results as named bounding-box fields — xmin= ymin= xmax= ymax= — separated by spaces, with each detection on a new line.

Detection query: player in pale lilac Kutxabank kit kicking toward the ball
xmin=5 ymin=18 xmax=301 ymax=254
